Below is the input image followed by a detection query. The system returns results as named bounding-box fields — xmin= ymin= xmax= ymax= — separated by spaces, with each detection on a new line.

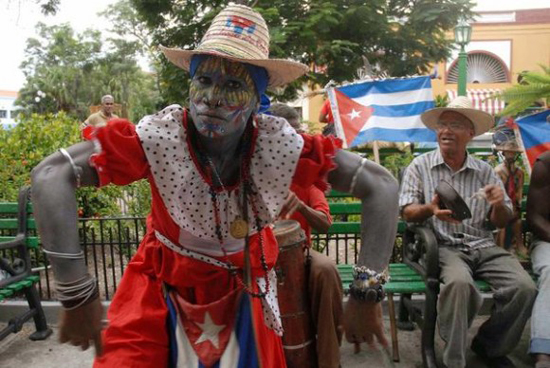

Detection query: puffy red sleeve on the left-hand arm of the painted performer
xmin=90 ymin=119 xmax=149 ymax=187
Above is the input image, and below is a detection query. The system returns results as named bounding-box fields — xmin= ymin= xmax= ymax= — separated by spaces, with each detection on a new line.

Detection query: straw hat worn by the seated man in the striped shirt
xmin=420 ymin=96 xmax=495 ymax=136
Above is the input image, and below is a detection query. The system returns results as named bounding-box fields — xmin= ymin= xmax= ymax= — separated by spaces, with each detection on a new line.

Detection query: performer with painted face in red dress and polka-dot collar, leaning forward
xmin=32 ymin=5 xmax=397 ymax=367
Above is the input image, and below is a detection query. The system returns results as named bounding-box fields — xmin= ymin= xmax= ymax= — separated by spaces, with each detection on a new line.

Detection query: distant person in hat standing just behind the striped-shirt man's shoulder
xmin=493 ymin=127 xmax=527 ymax=257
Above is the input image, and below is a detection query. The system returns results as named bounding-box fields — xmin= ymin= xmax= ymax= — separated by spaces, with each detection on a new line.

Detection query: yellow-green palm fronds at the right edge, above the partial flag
xmin=493 ymin=65 xmax=550 ymax=116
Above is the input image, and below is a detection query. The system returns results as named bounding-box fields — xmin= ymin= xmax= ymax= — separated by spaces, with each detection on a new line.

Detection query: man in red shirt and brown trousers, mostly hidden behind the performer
xmin=270 ymin=104 xmax=343 ymax=368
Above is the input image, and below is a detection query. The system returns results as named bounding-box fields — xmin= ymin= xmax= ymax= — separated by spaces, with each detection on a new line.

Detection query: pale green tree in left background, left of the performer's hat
xmin=16 ymin=23 xmax=162 ymax=121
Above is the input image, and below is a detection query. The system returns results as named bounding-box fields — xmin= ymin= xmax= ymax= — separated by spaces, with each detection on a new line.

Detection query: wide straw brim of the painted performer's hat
xmin=160 ymin=46 xmax=309 ymax=88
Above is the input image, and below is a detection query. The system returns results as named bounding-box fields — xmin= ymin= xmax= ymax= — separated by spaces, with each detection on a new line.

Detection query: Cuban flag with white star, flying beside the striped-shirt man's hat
xmin=327 ymin=76 xmax=437 ymax=147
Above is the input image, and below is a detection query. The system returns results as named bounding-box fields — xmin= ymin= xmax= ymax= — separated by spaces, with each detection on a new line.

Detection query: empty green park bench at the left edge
xmin=0 ymin=187 xmax=52 ymax=340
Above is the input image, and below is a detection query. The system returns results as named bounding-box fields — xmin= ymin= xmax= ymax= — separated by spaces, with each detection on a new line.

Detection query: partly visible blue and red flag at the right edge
xmin=516 ymin=109 xmax=550 ymax=167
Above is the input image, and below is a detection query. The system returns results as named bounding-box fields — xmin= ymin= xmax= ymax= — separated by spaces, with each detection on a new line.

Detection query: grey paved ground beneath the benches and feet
xmin=0 ymin=317 xmax=533 ymax=368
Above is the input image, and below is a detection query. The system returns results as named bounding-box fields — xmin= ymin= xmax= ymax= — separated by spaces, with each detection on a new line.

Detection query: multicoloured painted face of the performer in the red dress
xmin=189 ymin=57 xmax=258 ymax=138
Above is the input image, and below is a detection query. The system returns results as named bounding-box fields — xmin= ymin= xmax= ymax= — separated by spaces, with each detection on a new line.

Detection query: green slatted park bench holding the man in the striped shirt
xmin=320 ymin=185 xmax=529 ymax=368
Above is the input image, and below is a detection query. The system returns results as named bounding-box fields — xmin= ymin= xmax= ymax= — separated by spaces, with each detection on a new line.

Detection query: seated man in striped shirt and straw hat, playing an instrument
xmin=399 ymin=96 xmax=536 ymax=368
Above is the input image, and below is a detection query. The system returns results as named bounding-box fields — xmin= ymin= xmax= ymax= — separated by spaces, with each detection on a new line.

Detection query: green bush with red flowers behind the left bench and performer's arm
xmin=0 ymin=112 xmax=150 ymax=217
